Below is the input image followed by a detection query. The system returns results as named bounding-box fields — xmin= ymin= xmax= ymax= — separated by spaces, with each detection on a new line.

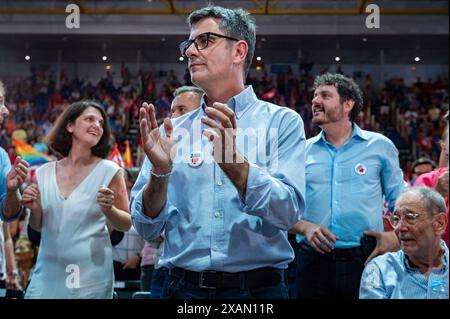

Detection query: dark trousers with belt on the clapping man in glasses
xmin=162 ymin=268 xmax=289 ymax=299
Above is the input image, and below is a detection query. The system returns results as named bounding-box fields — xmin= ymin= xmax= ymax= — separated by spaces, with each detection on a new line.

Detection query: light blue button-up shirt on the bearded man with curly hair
xmin=299 ymin=124 xmax=405 ymax=248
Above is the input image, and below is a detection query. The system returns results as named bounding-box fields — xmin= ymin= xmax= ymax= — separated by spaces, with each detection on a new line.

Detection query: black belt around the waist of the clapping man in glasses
xmin=169 ymin=267 xmax=285 ymax=289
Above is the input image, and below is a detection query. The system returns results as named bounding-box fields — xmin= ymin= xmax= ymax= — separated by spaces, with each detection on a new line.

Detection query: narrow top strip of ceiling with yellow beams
xmin=0 ymin=0 xmax=448 ymax=15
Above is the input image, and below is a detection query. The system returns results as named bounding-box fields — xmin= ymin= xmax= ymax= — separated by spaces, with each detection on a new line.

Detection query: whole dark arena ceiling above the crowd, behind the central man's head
xmin=0 ymin=0 xmax=449 ymax=64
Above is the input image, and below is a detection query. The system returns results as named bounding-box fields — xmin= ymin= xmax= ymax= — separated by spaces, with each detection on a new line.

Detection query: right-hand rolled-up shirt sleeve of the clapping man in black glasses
xmin=240 ymin=112 xmax=306 ymax=230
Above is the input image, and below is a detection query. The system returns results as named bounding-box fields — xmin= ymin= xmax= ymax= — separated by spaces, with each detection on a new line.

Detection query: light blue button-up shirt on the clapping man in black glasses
xmin=131 ymin=87 xmax=306 ymax=272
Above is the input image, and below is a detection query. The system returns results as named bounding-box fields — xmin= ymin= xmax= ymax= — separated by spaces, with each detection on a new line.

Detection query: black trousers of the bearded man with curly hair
xmin=297 ymin=241 xmax=364 ymax=299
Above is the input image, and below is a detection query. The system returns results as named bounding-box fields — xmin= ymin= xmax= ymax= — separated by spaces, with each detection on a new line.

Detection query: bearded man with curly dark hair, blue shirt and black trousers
xmin=291 ymin=73 xmax=405 ymax=299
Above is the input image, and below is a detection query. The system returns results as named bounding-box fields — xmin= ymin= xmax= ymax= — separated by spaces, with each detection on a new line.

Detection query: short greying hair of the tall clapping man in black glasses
xmin=187 ymin=6 xmax=256 ymax=78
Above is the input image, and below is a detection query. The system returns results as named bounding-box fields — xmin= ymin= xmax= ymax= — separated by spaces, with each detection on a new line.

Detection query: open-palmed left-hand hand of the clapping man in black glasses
xmin=139 ymin=102 xmax=176 ymax=174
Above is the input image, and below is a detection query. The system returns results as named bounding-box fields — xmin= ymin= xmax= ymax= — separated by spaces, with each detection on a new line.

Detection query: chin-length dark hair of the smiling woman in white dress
xmin=47 ymin=101 xmax=112 ymax=158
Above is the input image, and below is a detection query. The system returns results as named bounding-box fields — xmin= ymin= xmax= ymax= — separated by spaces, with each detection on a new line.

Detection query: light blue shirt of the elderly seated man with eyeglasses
xmin=359 ymin=240 xmax=448 ymax=300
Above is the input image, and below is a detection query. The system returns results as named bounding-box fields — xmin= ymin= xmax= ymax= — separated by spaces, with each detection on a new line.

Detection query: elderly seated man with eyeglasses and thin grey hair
xmin=359 ymin=186 xmax=449 ymax=300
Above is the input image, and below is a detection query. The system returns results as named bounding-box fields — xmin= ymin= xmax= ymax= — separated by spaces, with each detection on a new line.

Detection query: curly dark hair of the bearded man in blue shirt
xmin=314 ymin=73 xmax=364 ymax=122
